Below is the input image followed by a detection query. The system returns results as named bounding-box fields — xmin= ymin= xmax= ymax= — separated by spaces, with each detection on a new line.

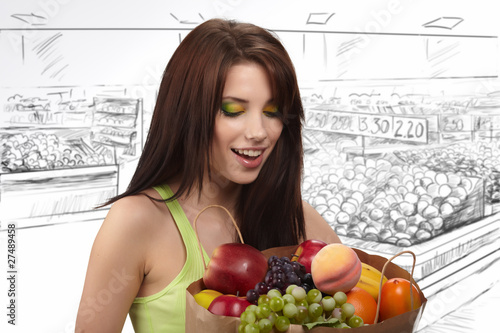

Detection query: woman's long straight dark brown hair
xmin=107 ymin=19 xmax=305 ymax=246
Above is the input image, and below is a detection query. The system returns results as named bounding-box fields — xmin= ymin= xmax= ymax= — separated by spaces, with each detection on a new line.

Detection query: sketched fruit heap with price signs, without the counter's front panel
xmin=304 ymin=96 xmax=500 ymax=241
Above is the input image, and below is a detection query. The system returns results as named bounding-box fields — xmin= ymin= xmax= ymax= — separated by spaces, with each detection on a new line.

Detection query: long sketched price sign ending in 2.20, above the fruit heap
xmin=306 ymin=110 xmax=428 ymax=143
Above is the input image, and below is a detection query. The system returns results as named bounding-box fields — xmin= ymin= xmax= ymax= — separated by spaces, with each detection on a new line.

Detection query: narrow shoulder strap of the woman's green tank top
xmin=150 ymin=184 xmax=210 ymax=263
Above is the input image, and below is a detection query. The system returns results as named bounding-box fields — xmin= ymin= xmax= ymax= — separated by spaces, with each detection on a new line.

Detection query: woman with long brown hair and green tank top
xmin=76 ymin=19 xmax=339 ymax=332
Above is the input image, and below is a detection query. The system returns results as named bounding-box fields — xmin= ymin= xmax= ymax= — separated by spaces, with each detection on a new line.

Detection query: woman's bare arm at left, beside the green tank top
xmin=75 ymin=197 xmax=148 ymax=333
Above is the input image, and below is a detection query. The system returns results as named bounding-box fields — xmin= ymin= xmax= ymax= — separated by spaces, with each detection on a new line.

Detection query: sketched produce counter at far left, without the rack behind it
xmin=0 ymin=127 xmax=118 ymax=229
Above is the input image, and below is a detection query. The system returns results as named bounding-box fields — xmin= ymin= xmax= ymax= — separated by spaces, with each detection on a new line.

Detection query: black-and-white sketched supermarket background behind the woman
xmin=0 ymin=0 xmax=500 ymax=332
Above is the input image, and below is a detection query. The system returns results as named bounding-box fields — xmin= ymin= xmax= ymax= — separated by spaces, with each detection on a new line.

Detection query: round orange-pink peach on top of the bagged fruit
xmin=311 ymin=243 xmax=362 ymax=295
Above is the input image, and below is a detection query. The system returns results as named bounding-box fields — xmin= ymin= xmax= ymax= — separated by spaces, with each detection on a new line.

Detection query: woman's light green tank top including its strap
xmin=129 ymin=185 xmax=210 ymax=333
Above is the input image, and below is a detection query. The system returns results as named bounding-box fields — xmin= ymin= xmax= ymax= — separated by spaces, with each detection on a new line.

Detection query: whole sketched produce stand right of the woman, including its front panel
xmin=303 ymin=92 xmax=500 ymax=330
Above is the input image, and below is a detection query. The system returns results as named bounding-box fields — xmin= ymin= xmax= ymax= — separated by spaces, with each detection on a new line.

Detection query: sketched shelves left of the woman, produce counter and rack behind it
xmin=0 ymin=92 xmax=146 ymax=229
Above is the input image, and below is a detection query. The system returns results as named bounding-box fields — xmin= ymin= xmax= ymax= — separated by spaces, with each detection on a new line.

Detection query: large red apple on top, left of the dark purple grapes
xmin=203 ymin=243 xmax=267 ymax=296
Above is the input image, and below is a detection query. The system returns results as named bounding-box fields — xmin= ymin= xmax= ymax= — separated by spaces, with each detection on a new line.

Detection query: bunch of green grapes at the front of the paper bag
xmin=238 ymin=285 xmax=364 ymax=333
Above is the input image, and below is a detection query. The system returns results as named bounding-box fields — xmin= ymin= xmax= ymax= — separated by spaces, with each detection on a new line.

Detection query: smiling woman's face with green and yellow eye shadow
xmin=211 ymin=63 xmax=283 ymax=184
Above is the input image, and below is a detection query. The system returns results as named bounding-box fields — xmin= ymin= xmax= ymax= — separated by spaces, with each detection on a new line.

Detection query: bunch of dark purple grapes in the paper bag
xmin=246 ymin=255 xmax=316 ymax=304
